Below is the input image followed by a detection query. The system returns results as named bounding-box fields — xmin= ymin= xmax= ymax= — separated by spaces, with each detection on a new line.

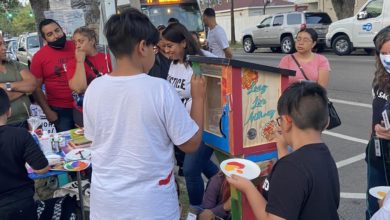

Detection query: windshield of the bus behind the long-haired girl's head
xmin=142 ymin=4 xmax=204 ymax=31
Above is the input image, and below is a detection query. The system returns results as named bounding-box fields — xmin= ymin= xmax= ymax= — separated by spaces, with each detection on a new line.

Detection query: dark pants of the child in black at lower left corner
xmin=0 ymin=198 xmax=38 ymax=220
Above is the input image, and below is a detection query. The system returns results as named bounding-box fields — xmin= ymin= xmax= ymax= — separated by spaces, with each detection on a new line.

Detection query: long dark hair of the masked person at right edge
xmin=372 ymin=26 xmax=390 ymax=95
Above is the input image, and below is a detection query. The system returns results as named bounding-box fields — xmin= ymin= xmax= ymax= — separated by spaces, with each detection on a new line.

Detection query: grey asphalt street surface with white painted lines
xmin=234 ymin=49 xmax=375 ymax=220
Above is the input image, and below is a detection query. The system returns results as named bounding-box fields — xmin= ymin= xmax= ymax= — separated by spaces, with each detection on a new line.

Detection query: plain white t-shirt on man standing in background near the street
xmin=207 ymin=25 xmax=229 ymax=58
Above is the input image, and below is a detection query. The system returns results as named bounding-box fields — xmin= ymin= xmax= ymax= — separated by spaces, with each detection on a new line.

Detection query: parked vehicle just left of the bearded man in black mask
xmin=16 ymin=32 xmax=40 ymax=67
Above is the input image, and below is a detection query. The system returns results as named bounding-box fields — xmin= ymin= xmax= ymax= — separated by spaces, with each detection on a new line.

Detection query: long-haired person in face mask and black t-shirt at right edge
xmin=366 ymin=26 xmax=390 ymax=219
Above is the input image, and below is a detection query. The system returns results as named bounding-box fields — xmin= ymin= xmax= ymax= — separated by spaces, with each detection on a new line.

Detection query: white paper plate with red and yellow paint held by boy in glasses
xmin=220 ymin=158 xmax=261 ymax=180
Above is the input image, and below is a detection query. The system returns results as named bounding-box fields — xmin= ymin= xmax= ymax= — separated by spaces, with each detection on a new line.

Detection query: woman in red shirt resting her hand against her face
xmin=66 ymin=27 xmax=112 ymax=127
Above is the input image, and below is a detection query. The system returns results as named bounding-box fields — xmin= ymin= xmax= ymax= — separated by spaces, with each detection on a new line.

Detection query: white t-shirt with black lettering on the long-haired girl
xmin=167 ymin=62 xmax=193 ymax=113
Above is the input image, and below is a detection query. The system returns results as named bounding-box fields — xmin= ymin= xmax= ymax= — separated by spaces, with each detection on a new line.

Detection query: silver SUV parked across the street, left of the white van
xmin=242 ymin=12 xmax=332 ymax=53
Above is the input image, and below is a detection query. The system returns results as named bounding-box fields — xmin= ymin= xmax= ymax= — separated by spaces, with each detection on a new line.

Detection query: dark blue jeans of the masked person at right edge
xmin=366 ymin=138 xmax=390 ymax=220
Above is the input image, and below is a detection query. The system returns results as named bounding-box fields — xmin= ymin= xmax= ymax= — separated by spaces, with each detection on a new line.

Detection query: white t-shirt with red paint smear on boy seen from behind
xmin=84 ymin=74 xmax=199 ymax=220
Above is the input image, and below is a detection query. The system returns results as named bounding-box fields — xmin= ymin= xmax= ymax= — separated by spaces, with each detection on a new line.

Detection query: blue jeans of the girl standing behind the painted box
xmin=183 ymin=141 xmax=219 ymax=206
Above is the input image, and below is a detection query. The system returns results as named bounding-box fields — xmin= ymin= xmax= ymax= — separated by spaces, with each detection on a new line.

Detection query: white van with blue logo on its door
xmin=326 ymin=0 xmax=390 ymax=56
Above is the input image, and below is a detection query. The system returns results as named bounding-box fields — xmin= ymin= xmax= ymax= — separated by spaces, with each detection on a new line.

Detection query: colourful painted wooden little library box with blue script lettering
xmin=189 ymin=56 xmax=295 ymax=220
